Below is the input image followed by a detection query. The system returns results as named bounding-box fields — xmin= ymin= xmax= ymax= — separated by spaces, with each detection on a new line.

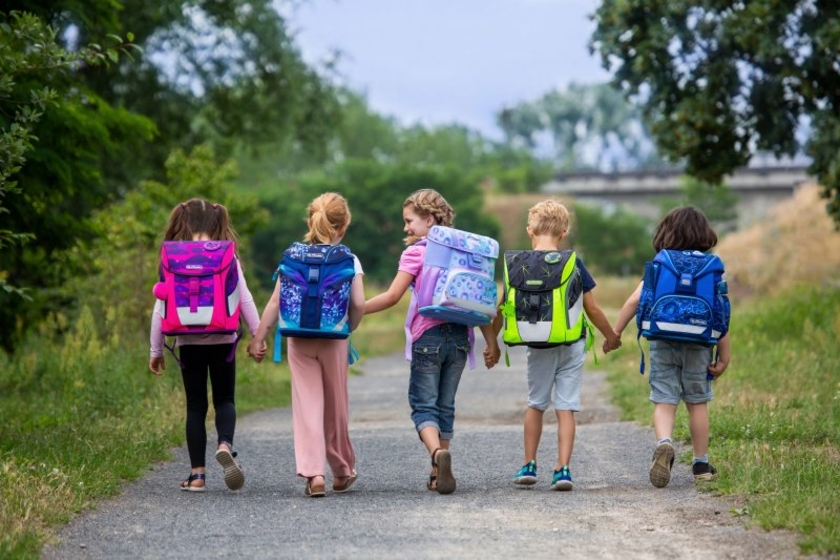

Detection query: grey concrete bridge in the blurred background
xmin=541 ymin=166 xmax=814 ymax=227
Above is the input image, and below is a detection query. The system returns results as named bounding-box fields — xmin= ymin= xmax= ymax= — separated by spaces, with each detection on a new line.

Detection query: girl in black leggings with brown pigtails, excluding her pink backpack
xmin=149 ymin=198 xmax=259 ymax=492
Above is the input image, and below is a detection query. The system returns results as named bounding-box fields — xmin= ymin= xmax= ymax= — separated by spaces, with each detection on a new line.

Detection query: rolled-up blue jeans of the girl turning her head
xmin=408 ymin=323 xmax=470 ymax=440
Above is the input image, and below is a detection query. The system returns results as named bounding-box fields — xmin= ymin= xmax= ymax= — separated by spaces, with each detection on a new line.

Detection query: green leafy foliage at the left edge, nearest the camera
xmin=0 ymin=12 xmax=153 ymax=347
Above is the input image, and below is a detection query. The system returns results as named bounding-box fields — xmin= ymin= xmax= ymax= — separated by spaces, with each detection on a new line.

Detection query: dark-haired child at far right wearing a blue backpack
xmin=604 ymin=206 xmax=730 ymax=488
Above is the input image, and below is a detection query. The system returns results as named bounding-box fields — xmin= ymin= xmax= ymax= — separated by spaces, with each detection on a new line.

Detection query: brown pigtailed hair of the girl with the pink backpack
xmin=163 ymin=198 xmax=239 ymax=246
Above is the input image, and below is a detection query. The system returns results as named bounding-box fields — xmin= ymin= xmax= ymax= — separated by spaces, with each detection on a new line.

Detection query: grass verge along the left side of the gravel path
xmin=0 ymin=291 xmax=408 ymax=558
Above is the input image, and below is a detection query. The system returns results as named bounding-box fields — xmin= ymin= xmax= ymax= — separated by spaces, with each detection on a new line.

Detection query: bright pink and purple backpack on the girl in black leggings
xmin=152 ymin=241 xmax=239 ymax=336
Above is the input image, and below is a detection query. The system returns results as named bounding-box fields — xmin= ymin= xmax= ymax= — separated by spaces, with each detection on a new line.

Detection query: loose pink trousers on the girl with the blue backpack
xmin=287 ymin=338 xmax=356 ymax=478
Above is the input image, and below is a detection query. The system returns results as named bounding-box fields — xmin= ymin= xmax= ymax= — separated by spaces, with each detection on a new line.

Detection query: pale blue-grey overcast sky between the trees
xmin=291 ymin=0 xmax=609 ymax=138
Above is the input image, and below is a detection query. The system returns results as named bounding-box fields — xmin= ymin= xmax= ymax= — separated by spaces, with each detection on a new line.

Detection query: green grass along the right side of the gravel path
xmin=603 ymin=288 xmax=840 ymax=554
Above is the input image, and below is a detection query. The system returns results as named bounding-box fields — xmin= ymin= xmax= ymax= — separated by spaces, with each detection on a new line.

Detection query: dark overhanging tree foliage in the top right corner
xmin=591 ymin=0 xmax=840 ymax=225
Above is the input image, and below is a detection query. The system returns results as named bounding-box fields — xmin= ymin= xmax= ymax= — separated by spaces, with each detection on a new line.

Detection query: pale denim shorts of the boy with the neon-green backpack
xmin=526 ymin=340 xmax=586 ymax=412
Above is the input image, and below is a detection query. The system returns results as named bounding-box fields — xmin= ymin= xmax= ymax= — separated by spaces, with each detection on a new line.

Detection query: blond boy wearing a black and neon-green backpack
xmin=493 ymin=199 xmax=621 ymax=490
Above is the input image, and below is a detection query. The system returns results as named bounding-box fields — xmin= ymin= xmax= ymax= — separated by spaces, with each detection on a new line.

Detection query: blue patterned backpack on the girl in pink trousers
xmin=272 ymin=242 xmax=356 ymax=362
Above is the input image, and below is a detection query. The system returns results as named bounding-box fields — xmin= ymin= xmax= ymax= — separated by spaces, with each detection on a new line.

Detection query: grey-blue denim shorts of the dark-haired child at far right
xmin=650 ymin=340 xmax=714 ymax=405
